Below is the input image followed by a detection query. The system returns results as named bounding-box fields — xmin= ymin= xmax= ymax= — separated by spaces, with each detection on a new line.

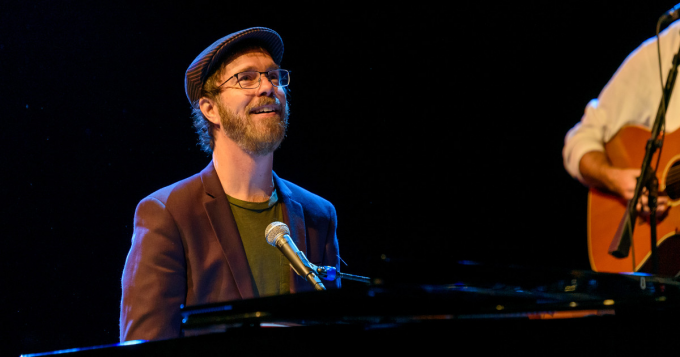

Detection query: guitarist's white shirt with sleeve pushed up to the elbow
xmin=562 ymin=21 xmax=680 ymax=182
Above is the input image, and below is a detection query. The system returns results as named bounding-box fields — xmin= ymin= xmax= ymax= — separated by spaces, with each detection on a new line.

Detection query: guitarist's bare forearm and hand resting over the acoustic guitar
xmin=579 ymin=151 xmax=669 ymax=215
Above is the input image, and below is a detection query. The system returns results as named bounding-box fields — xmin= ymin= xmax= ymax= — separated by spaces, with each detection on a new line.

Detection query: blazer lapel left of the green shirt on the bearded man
xmin=201 ymin=161 xmax=255 ymax=299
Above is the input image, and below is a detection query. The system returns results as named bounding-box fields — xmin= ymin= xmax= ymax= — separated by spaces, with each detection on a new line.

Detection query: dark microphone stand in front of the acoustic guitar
xmin=609 ymin=32 xmax=680 ymax=274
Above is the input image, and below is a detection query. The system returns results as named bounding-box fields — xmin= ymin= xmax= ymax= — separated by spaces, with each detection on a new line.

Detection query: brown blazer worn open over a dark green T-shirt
xmin=120 ymin=162 xmax=340 ymax=341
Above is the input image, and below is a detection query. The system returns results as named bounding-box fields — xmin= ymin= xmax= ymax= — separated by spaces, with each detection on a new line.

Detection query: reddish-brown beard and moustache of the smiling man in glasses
xmin=217 ymin=97 xmax=288 ymax=156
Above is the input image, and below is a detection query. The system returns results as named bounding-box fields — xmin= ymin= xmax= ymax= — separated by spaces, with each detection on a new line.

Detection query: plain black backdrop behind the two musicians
xmin=0 ymin=1 xmax=674 ymax=356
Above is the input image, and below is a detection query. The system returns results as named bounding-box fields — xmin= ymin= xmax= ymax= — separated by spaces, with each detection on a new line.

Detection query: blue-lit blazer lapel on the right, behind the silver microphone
xmin=274 ymin=173 xmax=309 ymax=293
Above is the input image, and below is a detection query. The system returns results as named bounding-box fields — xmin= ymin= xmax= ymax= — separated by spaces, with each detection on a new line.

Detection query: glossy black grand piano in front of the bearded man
xmin=19 ymin=262 xmax=680 ymax=357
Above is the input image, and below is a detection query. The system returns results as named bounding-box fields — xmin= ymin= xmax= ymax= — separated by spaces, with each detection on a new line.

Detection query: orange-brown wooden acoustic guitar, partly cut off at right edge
xmin=588 ymin=126 xmax=680 ymax=276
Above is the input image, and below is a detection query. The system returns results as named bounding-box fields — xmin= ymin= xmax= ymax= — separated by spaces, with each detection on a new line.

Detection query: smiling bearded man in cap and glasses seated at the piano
xmin=120 ymin=27 xmax=339 ymax=341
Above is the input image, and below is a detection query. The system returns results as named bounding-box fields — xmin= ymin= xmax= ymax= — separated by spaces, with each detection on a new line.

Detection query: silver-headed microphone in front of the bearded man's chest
xmin=264 ymin=222 xmax=326 ymax=290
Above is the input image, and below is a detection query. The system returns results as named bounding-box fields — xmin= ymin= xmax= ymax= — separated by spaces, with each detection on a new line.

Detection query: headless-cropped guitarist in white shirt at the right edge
xmin=562 ymin=21 xmax=680 ymax=270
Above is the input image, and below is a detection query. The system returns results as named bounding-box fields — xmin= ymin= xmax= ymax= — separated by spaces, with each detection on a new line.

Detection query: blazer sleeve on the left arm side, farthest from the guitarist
xmin=120 ymin=197 xmax=187 ymax=342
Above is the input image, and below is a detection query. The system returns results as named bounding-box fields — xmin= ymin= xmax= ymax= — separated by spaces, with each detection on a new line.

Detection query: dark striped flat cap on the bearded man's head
xmin=184 ymin=27 xmax=283 ymax=105
